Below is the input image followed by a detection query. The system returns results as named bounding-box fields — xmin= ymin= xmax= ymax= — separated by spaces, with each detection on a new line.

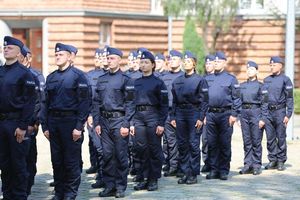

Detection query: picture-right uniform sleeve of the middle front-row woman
xmin=198 ymin=78 xmax=208 ymax=121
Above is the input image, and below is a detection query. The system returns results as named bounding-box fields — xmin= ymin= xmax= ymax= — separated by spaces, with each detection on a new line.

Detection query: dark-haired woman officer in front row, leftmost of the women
xmin=131 ymin=51 xmax=168 ymax=191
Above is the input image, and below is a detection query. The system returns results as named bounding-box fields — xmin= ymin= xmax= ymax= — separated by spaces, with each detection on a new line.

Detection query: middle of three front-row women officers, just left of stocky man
xmin=171 ymin=51 xmax=208 ymax=184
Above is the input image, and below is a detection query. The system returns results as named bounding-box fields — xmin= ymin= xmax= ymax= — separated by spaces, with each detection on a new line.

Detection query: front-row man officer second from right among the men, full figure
xmin=206 ymin=51 xmax=242 ymax=180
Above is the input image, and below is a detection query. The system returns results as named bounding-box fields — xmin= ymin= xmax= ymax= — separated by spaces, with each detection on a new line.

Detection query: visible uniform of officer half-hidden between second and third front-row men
xmin=87 ymin=68 xmax=105 ymax=178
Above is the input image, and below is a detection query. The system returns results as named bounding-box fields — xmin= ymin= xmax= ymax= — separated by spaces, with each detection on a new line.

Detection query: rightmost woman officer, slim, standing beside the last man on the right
xmin=239 ymin=61 xmax=267 ymax=175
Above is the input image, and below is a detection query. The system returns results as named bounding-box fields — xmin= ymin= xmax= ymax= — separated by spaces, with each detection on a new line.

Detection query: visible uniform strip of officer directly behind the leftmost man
xmin=27 ymin=67 xmax=45 ymax=195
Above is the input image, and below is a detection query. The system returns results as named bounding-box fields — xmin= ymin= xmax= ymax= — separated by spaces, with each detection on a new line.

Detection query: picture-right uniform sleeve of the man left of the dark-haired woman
xmin=122 ymin=78 xmax=135 ymax=128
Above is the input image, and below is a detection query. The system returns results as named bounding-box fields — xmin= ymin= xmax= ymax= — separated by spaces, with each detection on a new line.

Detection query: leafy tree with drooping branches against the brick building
xmin=162 ymin=0 xmax=238 ymax=54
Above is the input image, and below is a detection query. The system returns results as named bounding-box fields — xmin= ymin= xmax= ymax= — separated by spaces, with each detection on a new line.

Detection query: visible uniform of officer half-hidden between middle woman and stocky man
xmin=201 ymin=74 xmax=215 ymax=169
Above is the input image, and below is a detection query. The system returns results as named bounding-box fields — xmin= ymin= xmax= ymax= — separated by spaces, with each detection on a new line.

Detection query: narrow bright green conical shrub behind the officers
xmin=183 ymin=17 xmax=205 ymax=73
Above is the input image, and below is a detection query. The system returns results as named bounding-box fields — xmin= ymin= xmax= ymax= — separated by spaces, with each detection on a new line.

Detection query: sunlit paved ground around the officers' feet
xmin=0 ymin=116 xmax=300 ymax=200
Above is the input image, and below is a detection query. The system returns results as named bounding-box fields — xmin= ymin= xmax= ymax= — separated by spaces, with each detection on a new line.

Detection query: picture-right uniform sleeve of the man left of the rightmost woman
xmin=231 ymin=78 xmax=242 ymax=117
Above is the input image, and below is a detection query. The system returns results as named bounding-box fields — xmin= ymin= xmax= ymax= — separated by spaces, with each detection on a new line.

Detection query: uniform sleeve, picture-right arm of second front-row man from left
xmin=76 ymin=75 xmax=91 ymax=131
